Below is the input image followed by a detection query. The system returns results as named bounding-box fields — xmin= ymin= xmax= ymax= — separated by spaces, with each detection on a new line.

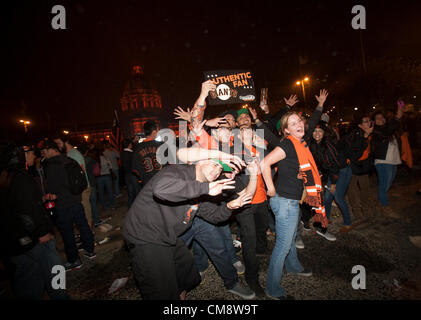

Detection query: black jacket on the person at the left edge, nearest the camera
xmin=0 ymin=170 xmax=52 ymax=257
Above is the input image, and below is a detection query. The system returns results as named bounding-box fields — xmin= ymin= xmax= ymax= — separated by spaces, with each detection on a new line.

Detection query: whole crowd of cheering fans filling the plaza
xmin=0 ymin=80 xmax=416 ymax=300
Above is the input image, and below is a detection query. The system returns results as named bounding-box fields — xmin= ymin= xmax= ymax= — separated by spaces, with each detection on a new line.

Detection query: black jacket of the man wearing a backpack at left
xmin=45 ymin=154 xmax=82 ymax=209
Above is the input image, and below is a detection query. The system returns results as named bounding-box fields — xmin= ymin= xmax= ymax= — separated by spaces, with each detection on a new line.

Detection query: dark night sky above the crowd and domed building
xmin=0 ymin=0 xmax=421 ymax=138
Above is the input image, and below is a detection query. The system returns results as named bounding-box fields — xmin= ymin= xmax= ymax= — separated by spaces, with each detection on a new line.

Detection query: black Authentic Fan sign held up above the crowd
xmin=204 ymin=70 xmax=256 ymax=105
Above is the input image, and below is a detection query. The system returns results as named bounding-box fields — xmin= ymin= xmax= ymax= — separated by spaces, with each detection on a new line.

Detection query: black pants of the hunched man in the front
xmin=128 ymin=239 xmax=200 ymax=300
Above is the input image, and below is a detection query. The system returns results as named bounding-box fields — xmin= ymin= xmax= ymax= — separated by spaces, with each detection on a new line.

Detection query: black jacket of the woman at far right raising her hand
xmin=372 ymin=119 xmax=400 ymax=160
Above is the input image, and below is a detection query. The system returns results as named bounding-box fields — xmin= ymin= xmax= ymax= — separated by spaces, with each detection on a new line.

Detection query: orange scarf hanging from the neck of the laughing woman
xmin=287 ymin=136 xmax=328 ymax=228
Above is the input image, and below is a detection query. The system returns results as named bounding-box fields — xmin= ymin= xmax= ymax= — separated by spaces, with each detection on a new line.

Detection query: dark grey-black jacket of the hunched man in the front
xmin=123 ymin=165 xmax=231 ymax=246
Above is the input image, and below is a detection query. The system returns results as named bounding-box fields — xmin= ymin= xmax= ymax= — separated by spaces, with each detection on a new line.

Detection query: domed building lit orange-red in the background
xmin=119 ymin=66 xmax=178 ymax=137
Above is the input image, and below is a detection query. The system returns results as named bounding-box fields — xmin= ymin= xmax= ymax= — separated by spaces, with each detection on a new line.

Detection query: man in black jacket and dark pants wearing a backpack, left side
xmin=43 ymin=141 xmax=96 ymax=270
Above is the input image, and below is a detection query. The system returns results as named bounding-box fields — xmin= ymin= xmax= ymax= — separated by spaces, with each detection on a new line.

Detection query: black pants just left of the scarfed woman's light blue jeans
xmin=236 ymin=205 xmax=259 ymax=284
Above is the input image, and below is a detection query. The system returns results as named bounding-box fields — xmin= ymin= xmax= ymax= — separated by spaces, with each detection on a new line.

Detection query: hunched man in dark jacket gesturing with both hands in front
xmin=123 ymin=150 xmax=250 ymax=300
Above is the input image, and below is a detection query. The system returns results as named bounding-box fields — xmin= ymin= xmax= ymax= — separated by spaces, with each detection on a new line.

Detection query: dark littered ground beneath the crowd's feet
xmin=3 ymin=164 xmax=421 ymax=300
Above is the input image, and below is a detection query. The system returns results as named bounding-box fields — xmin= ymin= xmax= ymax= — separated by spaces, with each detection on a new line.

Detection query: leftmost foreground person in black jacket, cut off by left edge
xmin=0 ymin=145 xmax=69 ymax=300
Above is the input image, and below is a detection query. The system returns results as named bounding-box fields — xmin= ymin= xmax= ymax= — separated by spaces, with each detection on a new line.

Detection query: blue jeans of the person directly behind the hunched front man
xmin=193 ymin=223 xmax=240 ymax=272
